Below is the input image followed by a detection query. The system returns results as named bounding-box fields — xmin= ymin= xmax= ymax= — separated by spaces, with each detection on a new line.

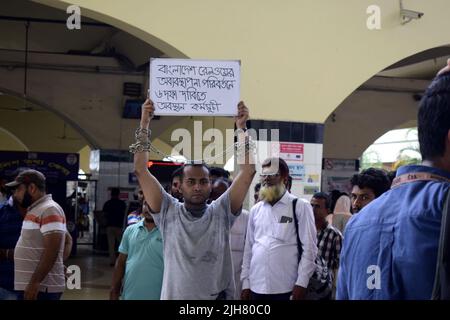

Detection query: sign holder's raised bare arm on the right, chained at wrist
xmin=229 ymin=101 xmax=256 ymax=214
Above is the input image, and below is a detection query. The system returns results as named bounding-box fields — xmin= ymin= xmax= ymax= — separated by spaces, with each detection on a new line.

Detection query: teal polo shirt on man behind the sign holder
xmin=119 ymin=220 xmax=164 ymax=300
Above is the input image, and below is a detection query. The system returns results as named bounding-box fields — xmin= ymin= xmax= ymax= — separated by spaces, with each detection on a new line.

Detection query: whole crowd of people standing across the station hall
xmin=0 ymin=60 xmax=450 ymax=300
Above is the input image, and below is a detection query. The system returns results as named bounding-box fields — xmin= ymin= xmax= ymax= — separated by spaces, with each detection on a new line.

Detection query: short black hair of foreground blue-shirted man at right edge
xmin=417 ymin=72 xmax=450 ymax=160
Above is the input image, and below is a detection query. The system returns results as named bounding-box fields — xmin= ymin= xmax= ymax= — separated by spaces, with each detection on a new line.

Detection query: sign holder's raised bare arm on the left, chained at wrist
xmin=134 ymin=99 xmax=162 ymax=213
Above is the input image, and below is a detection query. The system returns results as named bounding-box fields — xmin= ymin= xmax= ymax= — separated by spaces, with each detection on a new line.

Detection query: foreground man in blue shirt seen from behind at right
xmin=337 ymin=60 xmax=450 ymax=300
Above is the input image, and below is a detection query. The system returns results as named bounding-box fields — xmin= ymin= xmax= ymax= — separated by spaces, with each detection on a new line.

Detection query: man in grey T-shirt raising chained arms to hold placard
xmin=130 ymin=89 xmax=256 ymax=300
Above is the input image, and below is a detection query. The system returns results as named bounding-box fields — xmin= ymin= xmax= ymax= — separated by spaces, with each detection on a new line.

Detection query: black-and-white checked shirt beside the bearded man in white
xmin=317 ymin=224 xmax=342 ymax=270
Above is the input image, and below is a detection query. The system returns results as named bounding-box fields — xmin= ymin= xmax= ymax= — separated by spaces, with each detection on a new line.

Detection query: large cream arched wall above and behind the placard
xmin=35 ymin=0 xmax=450 ymax=123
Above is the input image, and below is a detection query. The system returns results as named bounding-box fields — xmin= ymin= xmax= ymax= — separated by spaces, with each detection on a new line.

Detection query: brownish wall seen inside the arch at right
xmin=324 ymin=47 xmax=450 ymax=158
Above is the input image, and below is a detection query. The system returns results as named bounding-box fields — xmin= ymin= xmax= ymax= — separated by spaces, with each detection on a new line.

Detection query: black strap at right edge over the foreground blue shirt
xmin=431 ymin=190 xmax=450 ymax=300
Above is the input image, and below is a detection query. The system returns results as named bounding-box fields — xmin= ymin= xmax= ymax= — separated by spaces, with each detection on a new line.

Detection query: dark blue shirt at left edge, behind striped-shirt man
xmin=0 ymin=202 xmax=23 ymax=291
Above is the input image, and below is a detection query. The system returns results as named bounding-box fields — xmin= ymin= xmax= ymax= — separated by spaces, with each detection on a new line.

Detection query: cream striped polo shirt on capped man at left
xmin=14 ymin=194 xmax=67 ymax=292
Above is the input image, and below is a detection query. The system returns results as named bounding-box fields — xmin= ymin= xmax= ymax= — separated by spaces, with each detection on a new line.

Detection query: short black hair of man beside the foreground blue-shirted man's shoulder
xmin=350 ymin=168 xmax=391 ymax=198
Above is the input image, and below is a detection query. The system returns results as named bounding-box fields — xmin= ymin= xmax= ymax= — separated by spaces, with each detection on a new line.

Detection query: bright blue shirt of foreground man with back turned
xmin=336 ymin=166 xmax=450 ymax=300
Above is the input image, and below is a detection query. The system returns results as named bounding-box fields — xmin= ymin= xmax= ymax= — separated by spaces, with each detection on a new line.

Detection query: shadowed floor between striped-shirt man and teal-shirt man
xmin=61 ymin=246 xmax=114 ymax=300
